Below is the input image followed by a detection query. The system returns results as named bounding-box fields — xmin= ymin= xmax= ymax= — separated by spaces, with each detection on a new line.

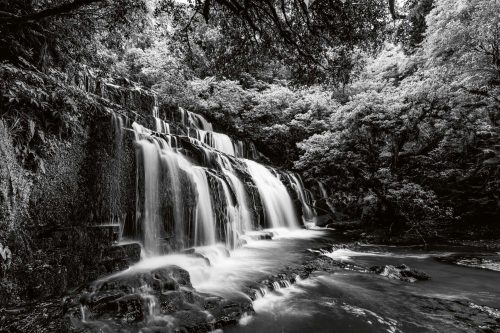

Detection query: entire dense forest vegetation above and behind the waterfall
xmin=0 ymin=0 xmax=500 ymax=244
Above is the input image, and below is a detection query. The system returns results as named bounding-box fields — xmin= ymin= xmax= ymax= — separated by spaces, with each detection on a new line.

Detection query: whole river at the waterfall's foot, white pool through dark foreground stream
xmin=102 ymin=229 xmax=500 ymax=333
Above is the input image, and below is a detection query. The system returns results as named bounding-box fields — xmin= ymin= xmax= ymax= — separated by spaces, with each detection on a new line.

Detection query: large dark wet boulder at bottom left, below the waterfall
xmin=63 ymin=265 xmax=253 ymax=332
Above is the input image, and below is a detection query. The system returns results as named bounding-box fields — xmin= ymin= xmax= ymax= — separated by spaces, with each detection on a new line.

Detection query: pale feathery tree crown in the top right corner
xmin=423 ymin=0 xmax=500 ymax=89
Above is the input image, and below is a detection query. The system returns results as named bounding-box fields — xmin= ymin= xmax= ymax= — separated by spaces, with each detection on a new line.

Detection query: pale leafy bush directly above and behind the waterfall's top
xmin=181 ymin=73 xmax=338 ymax=167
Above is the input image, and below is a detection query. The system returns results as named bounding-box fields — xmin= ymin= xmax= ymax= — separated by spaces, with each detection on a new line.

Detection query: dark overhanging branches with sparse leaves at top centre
xmin=148 ymin=0 xmax=388 ymax=84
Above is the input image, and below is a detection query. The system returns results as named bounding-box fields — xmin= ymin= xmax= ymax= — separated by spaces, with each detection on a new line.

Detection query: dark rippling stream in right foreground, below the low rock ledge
xmin=225 ymin=239 xmax=500 ymax=332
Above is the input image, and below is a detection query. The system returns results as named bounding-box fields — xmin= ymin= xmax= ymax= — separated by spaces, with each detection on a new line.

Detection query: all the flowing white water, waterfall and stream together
xmin=86 ymin=104 xmax=500 ymax=332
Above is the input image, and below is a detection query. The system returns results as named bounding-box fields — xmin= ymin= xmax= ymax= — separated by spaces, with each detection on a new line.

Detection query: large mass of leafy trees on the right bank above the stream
xmin=296 ymin=0 xmax=500 ymax=237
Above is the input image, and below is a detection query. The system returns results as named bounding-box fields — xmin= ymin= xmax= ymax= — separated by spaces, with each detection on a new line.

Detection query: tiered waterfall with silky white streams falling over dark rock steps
xmin=119 ymin=105 xmax=315 ymax=256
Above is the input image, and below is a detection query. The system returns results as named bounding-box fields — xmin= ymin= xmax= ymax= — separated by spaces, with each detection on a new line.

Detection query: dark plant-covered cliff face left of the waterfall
xmin=0 ymin=65 xmax=164 ymax=304
